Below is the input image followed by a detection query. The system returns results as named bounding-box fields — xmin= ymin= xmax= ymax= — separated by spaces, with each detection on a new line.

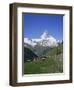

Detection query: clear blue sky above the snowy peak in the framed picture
xmin=23 ymin=13 xmax=63 ymax=40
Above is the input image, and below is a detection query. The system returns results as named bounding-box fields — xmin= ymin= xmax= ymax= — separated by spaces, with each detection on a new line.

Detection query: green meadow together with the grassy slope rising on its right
xmin=24 ymin=44 xmax=63 ymax=74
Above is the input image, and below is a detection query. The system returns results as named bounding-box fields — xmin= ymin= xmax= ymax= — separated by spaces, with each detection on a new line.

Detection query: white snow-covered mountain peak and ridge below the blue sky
xmin=24 ymin=31 xmax=58 ymax=47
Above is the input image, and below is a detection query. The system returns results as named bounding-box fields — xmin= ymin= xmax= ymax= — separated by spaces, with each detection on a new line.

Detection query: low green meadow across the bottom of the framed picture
xmin=24 ymin=56 xmax=63 ymax=74
